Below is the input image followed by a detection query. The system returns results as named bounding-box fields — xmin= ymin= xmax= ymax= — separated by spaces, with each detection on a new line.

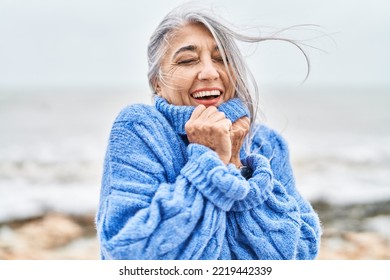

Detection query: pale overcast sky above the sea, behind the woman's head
xmin=0 ymin=0 xmax=390 ymax=88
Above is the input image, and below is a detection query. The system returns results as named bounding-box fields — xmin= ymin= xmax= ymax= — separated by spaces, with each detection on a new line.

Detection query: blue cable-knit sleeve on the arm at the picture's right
xmin=226 ymin=127 xmax=321 ymax=259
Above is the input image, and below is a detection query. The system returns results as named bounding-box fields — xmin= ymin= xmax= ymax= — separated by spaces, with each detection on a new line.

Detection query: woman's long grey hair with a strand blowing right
xmin=147 ymin=5 xmax=310 ymax=128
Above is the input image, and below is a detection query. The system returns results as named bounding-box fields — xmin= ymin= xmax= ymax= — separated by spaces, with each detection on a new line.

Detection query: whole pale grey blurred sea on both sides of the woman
xmin=0 ymin=87 xmax=390 ymax=222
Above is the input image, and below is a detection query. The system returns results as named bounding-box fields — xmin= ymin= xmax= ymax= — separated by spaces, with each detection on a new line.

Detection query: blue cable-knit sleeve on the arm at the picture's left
xmin=96 ymin=106 xmax=249 ymax=259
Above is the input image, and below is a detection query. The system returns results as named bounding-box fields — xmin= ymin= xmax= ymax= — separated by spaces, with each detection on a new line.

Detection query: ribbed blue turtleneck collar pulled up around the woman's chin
xmin=155 ymin=96 xmax=249 ymax=135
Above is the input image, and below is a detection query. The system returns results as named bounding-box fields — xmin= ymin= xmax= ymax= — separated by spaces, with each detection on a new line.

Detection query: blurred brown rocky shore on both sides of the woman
xmin=0 ymin=201 xmax=390 ymax=260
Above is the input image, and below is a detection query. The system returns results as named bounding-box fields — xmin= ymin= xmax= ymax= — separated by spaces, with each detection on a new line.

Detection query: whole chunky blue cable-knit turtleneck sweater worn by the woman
xmin=96 ymin=97 xmax=321 ymax=260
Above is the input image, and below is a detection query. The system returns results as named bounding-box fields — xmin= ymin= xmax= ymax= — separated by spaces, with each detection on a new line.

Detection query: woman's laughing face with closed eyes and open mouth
xmin=156 ymin=24 xmax=235 ymax=107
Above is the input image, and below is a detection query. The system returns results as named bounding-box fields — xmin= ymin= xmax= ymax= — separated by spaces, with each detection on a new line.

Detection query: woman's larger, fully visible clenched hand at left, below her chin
xmin=185 ymin=105 xmax=232 ymax=164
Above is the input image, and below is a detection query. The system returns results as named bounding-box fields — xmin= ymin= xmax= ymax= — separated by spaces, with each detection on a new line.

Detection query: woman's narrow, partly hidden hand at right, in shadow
xmin=229 ymin=117 xmax=250 ymax=168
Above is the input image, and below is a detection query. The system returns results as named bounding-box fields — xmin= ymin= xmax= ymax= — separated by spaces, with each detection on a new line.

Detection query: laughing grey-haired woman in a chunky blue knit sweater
xmin=96 ymin=4 xmax=320 ymax=259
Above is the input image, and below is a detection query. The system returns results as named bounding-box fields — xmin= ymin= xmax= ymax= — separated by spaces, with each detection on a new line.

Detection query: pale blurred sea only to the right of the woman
xmin=264 ymin=88 xmax=390 ymax=204
